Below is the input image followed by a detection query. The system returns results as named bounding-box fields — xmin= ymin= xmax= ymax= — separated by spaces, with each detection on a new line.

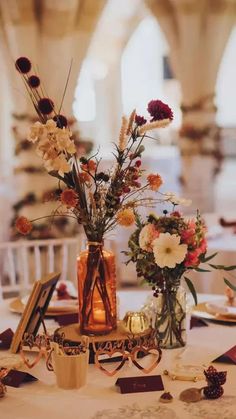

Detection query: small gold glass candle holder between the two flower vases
xmin=123 ymin=311 xmax=150 ymax=335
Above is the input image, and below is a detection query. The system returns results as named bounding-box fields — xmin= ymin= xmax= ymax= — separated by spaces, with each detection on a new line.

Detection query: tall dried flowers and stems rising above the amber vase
xmin=16 ymin=57 xmax=177 ymax=242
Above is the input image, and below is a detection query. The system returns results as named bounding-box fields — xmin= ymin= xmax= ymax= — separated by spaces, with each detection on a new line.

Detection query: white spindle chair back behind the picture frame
xmin=0 ymin=236 xmax=81 ymax=298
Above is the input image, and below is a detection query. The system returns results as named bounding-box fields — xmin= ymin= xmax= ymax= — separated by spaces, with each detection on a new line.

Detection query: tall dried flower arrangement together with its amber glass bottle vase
xmin=13 ymin=57 xmax=188 ymax=335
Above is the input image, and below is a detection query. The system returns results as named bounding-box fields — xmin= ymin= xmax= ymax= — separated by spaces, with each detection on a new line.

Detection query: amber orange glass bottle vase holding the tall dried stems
xmin=77 ymin=242 xmax=117 ymax=335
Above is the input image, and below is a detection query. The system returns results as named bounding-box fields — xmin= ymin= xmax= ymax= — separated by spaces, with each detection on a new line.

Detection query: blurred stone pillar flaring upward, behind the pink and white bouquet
xmin=146 ymin=0 xmax=236 ymax=212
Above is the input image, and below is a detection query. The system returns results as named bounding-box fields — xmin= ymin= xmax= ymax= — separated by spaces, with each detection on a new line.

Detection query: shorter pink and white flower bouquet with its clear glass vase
xmin=125 ymin=208 xmax=236 ymax=348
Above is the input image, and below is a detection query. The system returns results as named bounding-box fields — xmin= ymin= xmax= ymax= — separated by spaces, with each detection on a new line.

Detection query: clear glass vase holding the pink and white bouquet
xmin=143 ymin=285 xmax=187 ymax=349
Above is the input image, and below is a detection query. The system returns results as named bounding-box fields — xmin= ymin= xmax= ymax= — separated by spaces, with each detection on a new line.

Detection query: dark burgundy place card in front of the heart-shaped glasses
xmin=116 ymin=375 xmax=164 ymax=394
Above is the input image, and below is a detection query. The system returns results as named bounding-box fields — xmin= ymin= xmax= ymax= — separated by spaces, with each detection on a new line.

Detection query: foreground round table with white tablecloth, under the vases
xmin=0 ymin=290 xmax=236 ymax=419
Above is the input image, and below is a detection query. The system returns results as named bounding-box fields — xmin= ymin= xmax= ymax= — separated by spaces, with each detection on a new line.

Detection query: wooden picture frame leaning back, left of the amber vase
xmin=10 ymin=272 xmax=61 ymax=353
